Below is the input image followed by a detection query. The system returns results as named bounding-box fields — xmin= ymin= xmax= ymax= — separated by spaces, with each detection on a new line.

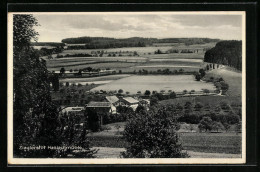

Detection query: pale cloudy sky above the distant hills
xmin=33 ymin=12 xmax=242 ymax=42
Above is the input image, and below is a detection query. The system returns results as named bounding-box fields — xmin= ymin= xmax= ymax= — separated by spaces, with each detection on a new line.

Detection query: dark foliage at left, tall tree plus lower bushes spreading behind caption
xmin=13 ymin=14 xmax=95 ymax=158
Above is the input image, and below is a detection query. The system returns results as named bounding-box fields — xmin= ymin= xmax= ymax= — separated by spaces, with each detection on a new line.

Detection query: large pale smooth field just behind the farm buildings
xmin=92 ymin=75 xmax=215 ymax=94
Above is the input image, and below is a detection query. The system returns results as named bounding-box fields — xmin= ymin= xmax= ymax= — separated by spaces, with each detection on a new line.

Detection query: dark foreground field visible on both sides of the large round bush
xmin=88 ymin=123 xmax=241 ymax=154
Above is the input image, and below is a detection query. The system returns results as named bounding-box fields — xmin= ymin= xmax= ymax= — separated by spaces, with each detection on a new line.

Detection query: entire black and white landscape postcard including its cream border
xmin=8 ymin=11 xmax=246 ymax=164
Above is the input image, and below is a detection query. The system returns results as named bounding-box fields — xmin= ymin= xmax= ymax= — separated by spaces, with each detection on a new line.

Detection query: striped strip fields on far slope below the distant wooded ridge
xmin=42 ymin=44 xmax=209 ymax=72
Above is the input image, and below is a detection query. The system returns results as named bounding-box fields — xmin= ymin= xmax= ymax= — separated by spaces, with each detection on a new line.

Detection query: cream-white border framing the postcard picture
xmin=7 ymin=11 xmax=246 ymax=165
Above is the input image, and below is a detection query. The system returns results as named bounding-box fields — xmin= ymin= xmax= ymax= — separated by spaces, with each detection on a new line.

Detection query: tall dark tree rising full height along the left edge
xmin=13 ymin=14 xmax=60 ymax=157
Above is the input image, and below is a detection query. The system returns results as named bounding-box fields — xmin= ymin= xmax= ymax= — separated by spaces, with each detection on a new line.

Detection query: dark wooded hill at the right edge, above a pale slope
xmin=204 ymin=40 xmax=242 ymax=70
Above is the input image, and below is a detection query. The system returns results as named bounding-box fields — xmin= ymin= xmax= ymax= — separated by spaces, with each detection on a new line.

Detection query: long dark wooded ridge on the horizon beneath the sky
xmin=62 ymin=37 xmax=219 ymax=49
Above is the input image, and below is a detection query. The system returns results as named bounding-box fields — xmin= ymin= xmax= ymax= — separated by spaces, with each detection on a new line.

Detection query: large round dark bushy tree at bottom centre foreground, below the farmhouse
xmin=121 ymin=107 xmax=188 ymax=158
